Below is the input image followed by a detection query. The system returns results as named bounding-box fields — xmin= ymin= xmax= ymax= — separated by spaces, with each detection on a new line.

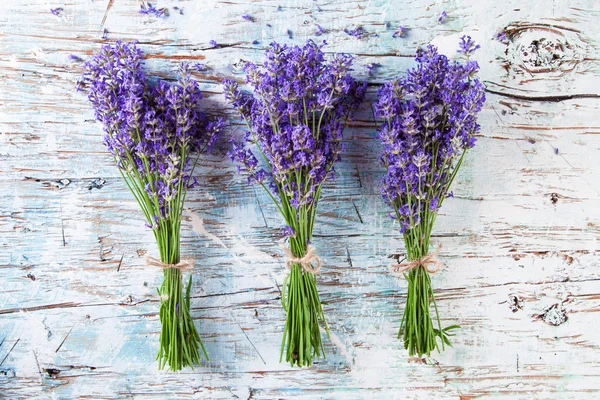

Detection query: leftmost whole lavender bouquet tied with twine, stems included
xmin=81 ymin=42 xmax=224 ymax=371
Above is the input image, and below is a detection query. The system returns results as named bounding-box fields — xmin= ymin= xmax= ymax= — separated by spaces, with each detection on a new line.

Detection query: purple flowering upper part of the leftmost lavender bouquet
xmin=81 ymin=41 xmax=225 ymax=229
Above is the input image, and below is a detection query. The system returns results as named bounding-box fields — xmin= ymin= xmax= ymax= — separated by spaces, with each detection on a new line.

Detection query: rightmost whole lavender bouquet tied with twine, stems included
xmin=375 ymin=37 xmax=485 ymax=357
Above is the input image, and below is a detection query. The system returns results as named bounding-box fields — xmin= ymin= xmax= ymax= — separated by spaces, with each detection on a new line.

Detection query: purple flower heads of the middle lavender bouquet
xmin=223 ymin=41 xmax=365 ymax=214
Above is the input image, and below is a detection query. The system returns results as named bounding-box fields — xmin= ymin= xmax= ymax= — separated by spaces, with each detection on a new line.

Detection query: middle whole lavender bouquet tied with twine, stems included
xmin=224 ymin=41 xmax=366 ymax=367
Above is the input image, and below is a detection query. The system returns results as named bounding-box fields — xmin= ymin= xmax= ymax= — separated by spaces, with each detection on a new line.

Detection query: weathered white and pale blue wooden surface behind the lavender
xmin=0 ymin=0 xmax=600 ymax=399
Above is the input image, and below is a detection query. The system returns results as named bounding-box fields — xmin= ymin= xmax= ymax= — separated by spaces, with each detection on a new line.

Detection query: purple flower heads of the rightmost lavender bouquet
xmin=375 ymin=37 xmax=485 ymax=233
